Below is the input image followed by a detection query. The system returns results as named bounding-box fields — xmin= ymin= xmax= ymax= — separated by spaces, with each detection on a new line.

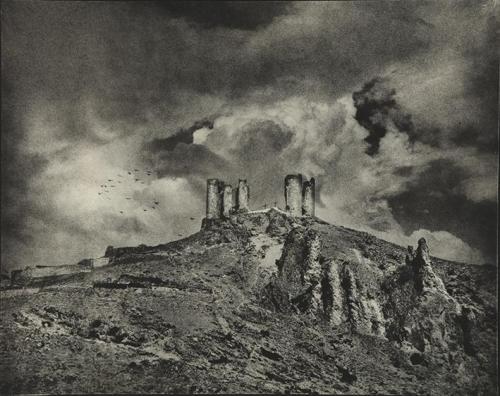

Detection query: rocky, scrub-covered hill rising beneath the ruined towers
xmin=0 ymin=210 xmax=497 ymax=395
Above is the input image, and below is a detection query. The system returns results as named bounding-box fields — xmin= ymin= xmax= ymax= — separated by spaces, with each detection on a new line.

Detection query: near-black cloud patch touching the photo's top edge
xmin=145 ymin=1 xmax=290 ymax=30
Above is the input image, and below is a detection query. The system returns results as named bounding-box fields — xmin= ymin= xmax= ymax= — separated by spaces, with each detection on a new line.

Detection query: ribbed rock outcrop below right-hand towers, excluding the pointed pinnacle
xmin=265 ymin=226 xmax=385 ymax=337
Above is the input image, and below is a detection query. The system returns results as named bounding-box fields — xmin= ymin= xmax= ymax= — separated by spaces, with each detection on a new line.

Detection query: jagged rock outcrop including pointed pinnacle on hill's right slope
xmin=263 ymin=225 xmax=484 ymax=362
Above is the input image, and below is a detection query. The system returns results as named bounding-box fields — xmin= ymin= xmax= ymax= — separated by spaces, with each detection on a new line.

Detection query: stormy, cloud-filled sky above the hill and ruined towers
xmin=1 ymin=0 xmax=499 ymax=270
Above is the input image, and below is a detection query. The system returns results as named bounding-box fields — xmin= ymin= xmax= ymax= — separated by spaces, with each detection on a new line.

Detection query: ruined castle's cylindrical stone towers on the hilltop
xmin=206 ymin=174 xmax=316 ymax=219
